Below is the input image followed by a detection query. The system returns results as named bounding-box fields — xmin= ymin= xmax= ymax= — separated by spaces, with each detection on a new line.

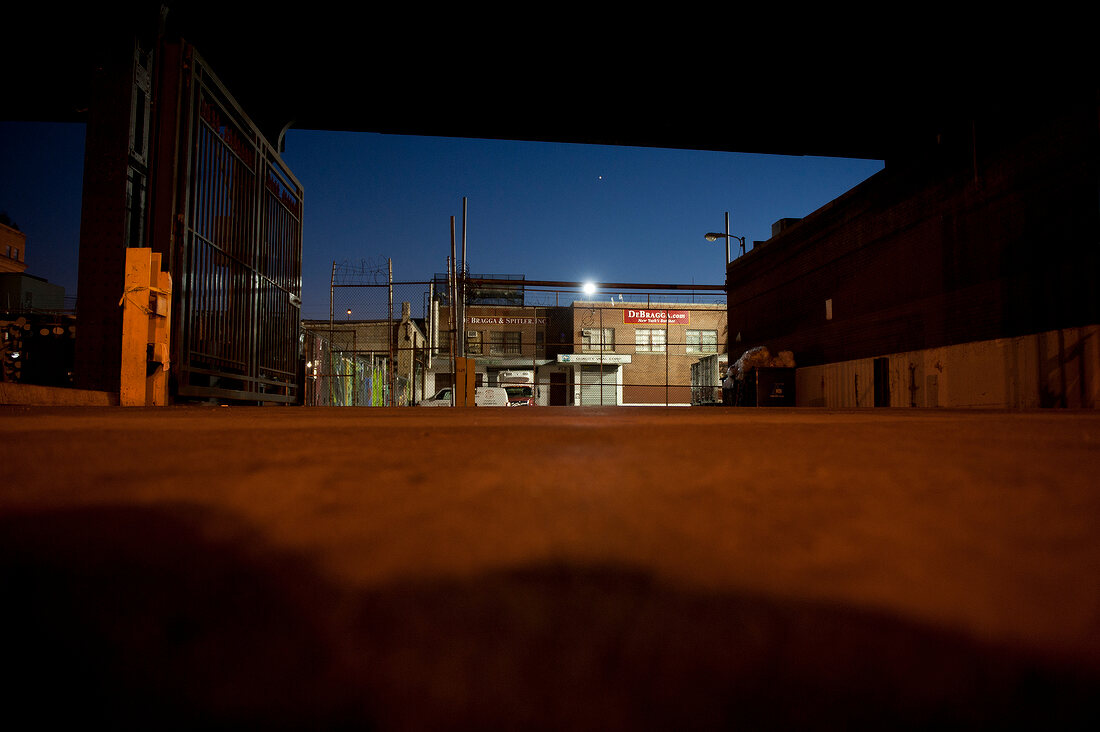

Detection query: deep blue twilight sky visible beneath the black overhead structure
xmin=0 ymin=122 xmax=882 ymax=317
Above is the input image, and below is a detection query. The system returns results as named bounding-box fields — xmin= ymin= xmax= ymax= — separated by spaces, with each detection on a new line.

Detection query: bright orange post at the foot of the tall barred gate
xmin=119 ymin=248 xmax=172 ymax=406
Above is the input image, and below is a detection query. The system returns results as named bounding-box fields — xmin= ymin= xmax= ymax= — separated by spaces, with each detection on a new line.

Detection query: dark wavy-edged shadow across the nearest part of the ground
xmin=0 ymin=506 xmax=1100 ymax=730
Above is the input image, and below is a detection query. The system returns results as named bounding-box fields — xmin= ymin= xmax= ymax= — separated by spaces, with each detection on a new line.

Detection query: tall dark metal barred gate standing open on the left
xmin=175 ymin=50 xmax=303 ymax=403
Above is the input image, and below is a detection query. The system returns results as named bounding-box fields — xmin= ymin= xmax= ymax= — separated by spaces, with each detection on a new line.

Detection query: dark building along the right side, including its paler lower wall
xmin=726 ymin=99 xmax=1100 ymax=407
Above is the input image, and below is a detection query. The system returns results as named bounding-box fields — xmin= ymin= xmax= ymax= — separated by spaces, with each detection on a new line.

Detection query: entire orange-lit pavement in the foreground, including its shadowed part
xmin=0 ymin=407 xmax=1100 ymax=730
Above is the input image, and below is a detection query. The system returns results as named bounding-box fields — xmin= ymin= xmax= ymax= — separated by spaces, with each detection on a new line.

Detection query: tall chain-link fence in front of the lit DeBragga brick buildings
xmin=303 ymin=265 xmax=736 ymax=406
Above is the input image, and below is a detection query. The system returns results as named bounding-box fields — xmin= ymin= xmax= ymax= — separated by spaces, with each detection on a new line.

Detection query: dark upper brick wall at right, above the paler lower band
xmin=727 ymin=105 xmax=1100 ymax=367
